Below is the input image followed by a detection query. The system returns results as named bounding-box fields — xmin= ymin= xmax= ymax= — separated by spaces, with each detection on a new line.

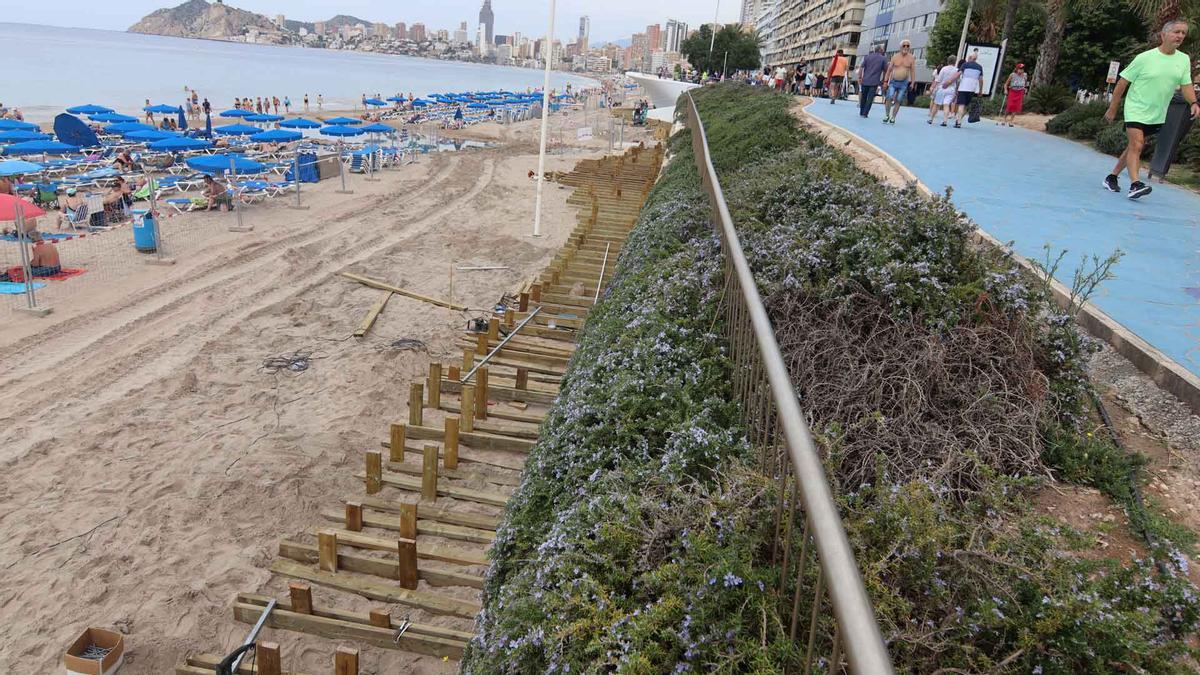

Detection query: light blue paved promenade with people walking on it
xmin=806 ymin=100 xmax=1200 ymax=375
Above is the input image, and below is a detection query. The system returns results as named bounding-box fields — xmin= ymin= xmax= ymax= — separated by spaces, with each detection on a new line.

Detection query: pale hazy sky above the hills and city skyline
xmin=7 ymin=0 xmax=742 ymax=44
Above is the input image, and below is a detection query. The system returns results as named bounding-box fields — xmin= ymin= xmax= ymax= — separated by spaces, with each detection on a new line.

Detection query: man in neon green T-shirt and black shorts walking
xmin=1104 ymin=19 xmax=1200 ymax=199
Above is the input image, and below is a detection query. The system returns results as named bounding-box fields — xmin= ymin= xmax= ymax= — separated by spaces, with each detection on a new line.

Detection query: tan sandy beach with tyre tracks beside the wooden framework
xmin=0 ymin=102 xmax=647 ymax=674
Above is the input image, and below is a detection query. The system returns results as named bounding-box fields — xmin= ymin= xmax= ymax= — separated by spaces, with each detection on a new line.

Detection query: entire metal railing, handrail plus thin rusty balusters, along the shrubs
xmin=684 ymin=94 xmax=893 ymax=675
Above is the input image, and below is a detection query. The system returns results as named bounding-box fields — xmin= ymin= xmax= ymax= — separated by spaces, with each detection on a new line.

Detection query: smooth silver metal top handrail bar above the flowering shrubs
xmin=684 ymin=92 xmax=893 ymax=675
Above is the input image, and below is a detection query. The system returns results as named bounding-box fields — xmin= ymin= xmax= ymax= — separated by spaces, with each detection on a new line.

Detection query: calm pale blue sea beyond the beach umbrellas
xmin=0 ymin=23 xmax=596 ymax=120
